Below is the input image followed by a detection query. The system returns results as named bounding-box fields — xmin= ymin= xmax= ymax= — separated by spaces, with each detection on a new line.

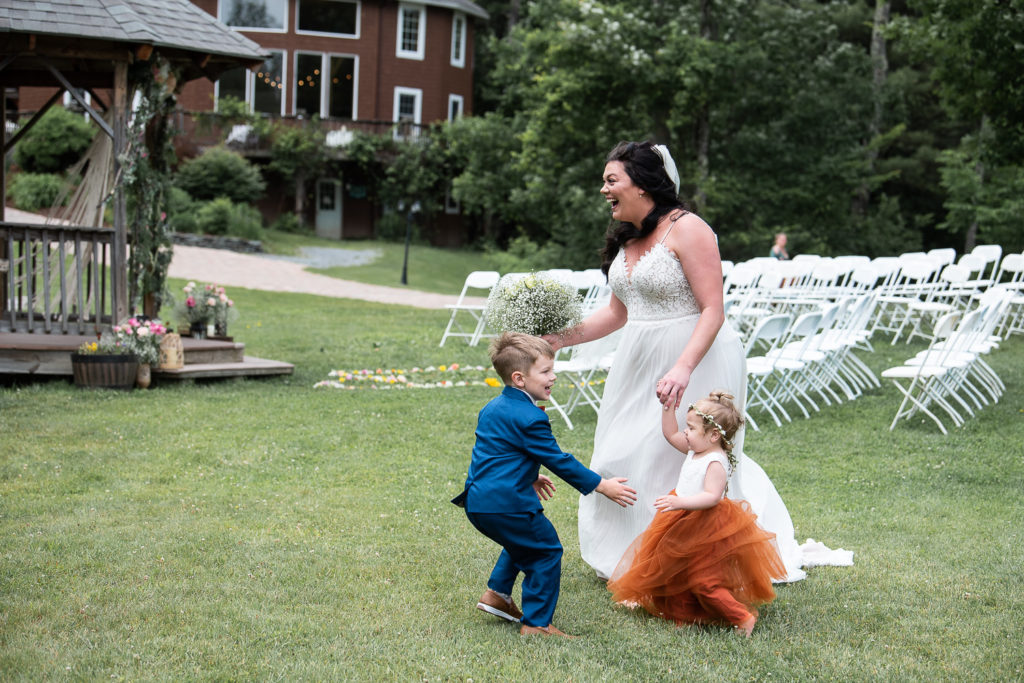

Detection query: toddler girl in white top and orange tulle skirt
xmin=608 ymin=391 xmax=785 ymax=638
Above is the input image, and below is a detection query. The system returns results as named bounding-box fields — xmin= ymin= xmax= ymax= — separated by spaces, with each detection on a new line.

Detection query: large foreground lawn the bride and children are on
xmin=0 ymin=283 xmax=1024 ymax=681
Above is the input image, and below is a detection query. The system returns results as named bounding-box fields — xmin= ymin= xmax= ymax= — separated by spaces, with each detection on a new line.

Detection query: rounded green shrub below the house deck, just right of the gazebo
xmin=174 ymin=147 xmax=266 ymax=202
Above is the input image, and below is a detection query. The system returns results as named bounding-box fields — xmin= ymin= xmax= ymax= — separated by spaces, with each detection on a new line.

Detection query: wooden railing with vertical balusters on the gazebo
xmin=0 ymin=222 xmax=126 ymax=335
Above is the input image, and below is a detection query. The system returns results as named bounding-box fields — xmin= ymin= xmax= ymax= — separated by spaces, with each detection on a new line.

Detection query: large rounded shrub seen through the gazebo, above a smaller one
xmin=14 ymin=106 xmax=95 ymax=173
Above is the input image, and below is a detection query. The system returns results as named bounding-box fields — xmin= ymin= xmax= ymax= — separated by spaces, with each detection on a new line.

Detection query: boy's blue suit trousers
xmin=466 ymin=511 xmax=562 ymax=628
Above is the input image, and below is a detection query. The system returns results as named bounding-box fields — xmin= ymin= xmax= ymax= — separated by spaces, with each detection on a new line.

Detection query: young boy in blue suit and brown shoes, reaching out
xmin=452 ymin=332 xmax=636 ymax=637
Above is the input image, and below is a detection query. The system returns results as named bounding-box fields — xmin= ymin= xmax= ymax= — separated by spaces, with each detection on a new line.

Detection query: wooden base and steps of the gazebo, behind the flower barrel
xmin=0 ymin=332 xmax=295 ymax=381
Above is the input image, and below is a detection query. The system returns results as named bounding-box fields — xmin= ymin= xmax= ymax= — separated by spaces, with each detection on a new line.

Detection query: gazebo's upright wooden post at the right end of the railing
xmin=111 ymin=61 xmax=128 ymax=325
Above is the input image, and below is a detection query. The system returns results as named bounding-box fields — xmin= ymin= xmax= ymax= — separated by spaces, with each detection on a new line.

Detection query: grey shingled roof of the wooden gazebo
xmin=0 ymin=0 xmax=268 ymax=62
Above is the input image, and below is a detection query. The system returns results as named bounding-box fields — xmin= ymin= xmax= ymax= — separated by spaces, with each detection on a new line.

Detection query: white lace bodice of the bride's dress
xmin=608 ymin=242 xmax=700 ymax=321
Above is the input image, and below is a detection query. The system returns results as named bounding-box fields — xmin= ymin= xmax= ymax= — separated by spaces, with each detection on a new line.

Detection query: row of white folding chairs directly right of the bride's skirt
xmin=744 ymin=292 xmax=880 ymax=429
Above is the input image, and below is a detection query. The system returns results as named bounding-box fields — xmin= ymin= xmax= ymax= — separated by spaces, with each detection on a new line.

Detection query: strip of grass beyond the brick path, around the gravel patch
xmin=263 ymin=230 xmax=494 ymax=294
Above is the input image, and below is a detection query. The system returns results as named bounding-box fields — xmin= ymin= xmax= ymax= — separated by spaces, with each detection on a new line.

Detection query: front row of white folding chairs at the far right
xmin=882 ymin=288 xmax=1014 ymax=434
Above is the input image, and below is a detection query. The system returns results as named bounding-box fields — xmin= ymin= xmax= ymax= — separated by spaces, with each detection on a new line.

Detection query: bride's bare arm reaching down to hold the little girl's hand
xmin=656 ymin=213 xmax=732 ymax=410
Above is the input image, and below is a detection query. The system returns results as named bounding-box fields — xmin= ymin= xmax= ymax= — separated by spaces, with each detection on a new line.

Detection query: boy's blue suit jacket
xmin=452 ymin=386 xmax=601 ymax=512
